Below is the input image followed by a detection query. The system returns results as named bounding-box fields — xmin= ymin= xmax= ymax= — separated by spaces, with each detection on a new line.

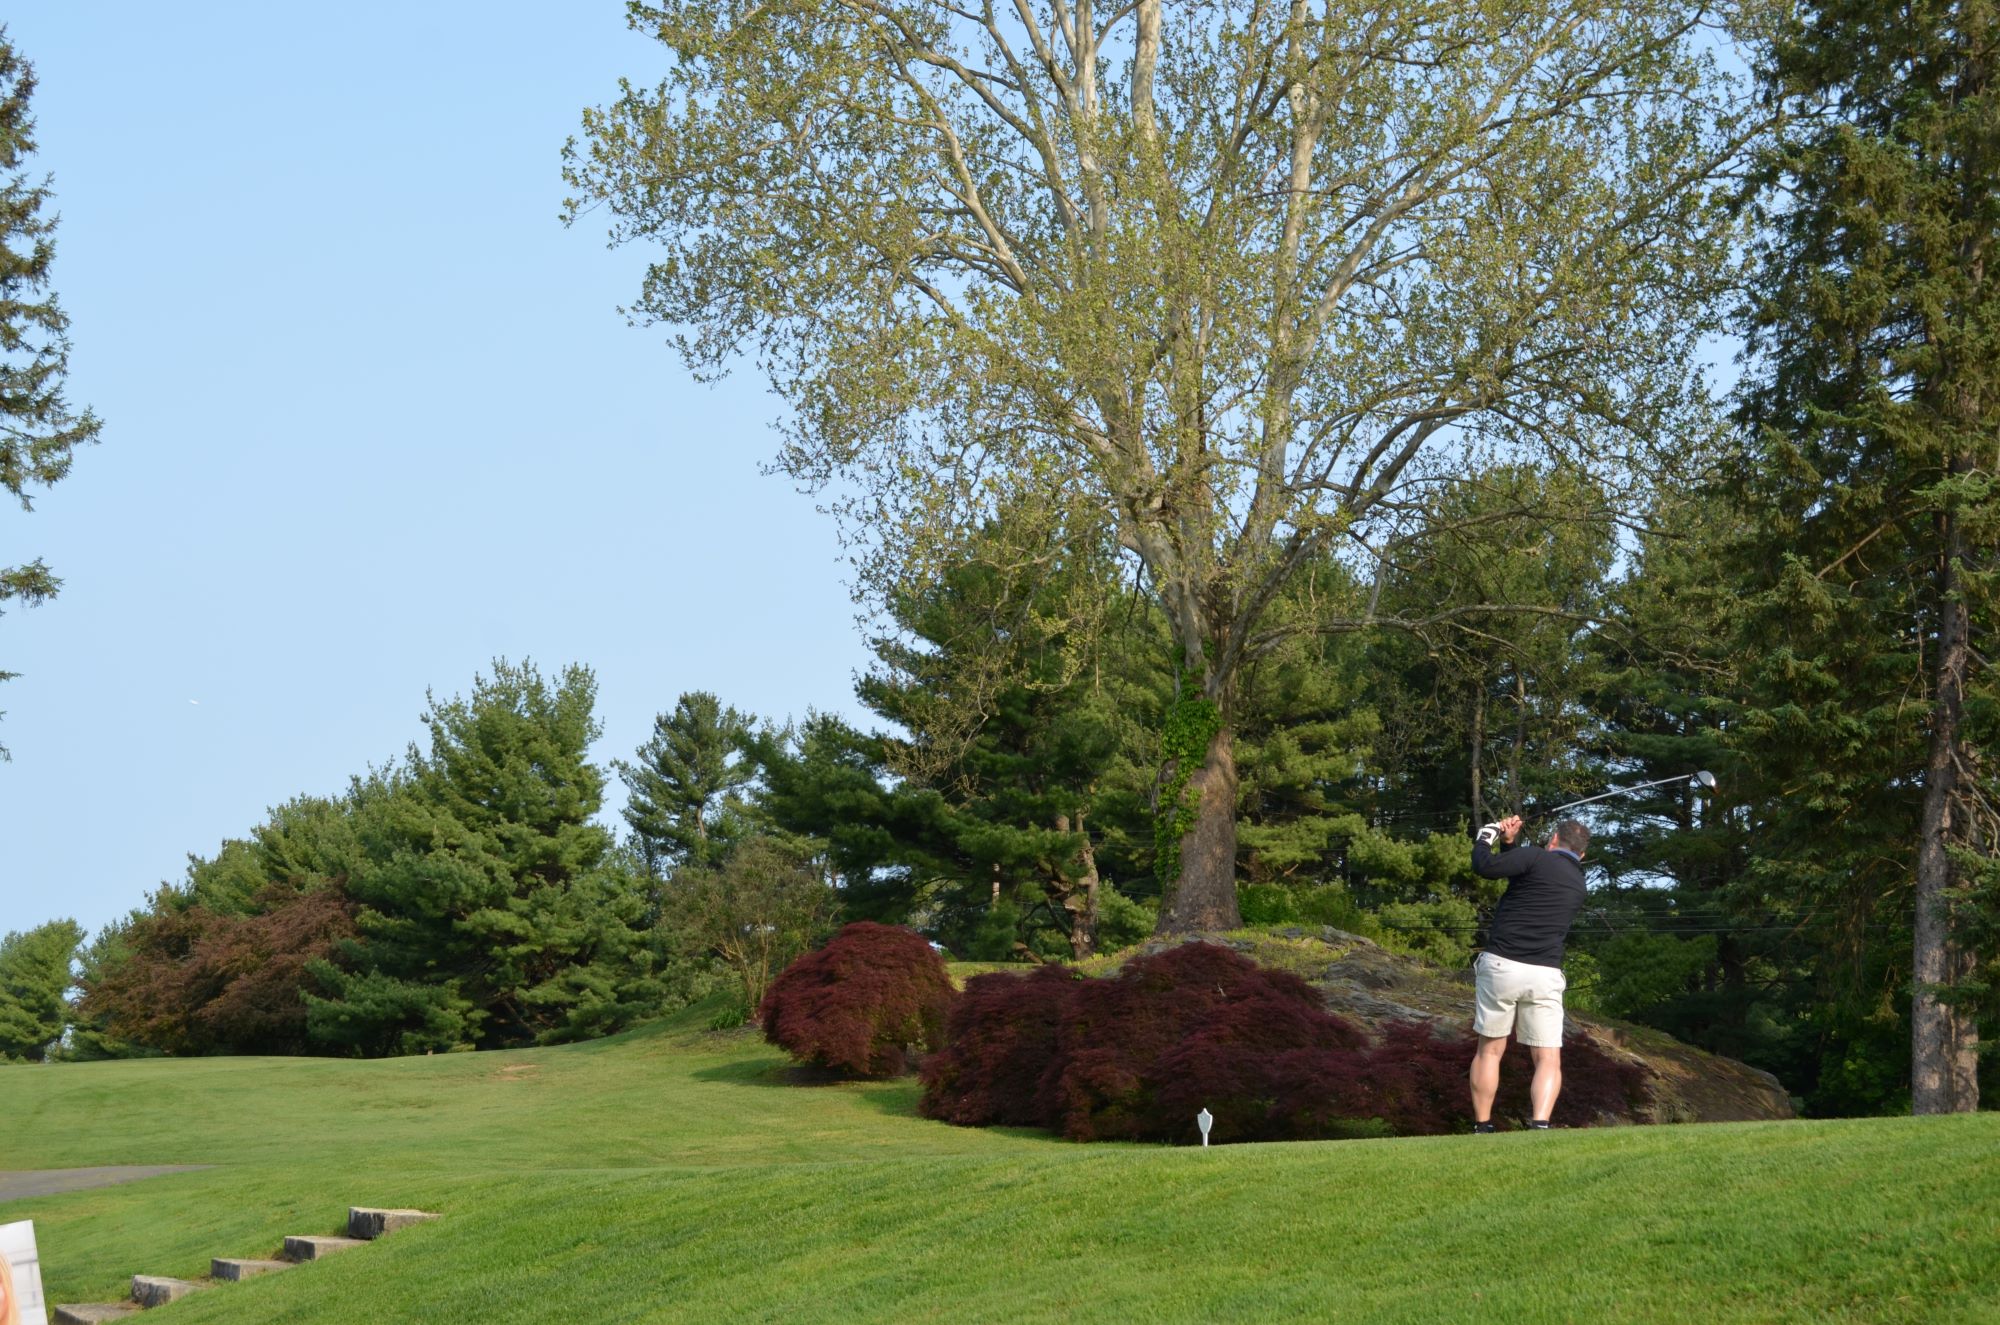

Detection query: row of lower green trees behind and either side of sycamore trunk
xmin=0 ymin=438 xmax=1986 ymax=1113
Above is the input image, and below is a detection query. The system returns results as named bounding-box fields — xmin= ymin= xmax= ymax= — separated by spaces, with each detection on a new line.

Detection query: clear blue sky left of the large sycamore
xmin=0 ymin=0 xmax=864 ymax=933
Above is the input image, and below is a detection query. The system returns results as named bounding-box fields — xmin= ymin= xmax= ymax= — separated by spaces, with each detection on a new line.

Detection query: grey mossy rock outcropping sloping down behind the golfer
xmin=1094 ymin=929 xmax=1794 ymax=1123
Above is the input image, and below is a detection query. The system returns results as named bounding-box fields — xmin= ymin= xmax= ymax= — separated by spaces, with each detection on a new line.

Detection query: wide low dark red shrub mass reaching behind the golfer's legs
xmin=920 ymin=943 xmax=1646 ymax=1141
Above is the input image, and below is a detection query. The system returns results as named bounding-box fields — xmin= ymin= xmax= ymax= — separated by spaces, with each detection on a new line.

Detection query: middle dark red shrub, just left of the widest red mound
xmin=918 ymin=967 xmax=1078 ymax=1127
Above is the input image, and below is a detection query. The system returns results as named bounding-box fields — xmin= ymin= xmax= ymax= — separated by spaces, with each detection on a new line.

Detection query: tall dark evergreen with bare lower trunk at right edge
xmin=1742 ymin=0 xmax=2000 ymax=1113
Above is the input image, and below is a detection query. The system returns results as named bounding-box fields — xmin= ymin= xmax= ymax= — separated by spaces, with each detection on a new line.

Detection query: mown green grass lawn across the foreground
xmin=0 ymin=1015 xmax=2000 ymax=1325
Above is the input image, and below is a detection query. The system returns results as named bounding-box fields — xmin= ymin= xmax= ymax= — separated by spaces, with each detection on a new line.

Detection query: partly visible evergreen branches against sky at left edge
xmin=0 ymin=26 xmax=102 ymax=759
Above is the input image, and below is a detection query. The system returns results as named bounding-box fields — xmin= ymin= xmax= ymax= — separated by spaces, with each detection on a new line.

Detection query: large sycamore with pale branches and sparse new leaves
xmin=566 ymin=0 xmax=1746 ymax=931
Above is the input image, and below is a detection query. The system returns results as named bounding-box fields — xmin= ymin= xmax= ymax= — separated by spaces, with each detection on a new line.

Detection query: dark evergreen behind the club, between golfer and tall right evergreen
xmin=1572 ymin=490 xmax=1832 ymax=1115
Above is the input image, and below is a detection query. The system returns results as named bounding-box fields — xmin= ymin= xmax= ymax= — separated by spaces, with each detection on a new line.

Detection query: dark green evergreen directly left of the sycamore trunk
xmin=856 ymin=536 xmax=1178 ymax=957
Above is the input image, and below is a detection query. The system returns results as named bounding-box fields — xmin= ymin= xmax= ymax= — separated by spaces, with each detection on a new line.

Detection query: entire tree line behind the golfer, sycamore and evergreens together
xmin=10 ymin=0 xmax=2000 ymax=1113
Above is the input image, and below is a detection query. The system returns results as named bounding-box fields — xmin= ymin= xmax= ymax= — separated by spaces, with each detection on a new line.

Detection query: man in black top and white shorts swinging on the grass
xmin=1472 ymin=815 xmax=1590 ymax=1131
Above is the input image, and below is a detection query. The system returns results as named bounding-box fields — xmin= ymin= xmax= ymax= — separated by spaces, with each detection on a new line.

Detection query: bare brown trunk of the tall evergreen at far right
xmin=1910 ymin=464 xmax=1980 ymax=1113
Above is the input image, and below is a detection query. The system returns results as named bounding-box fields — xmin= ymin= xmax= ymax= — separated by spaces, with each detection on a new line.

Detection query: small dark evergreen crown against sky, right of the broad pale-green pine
xmin=614 ymin=691 xmax=756 ymax=879
